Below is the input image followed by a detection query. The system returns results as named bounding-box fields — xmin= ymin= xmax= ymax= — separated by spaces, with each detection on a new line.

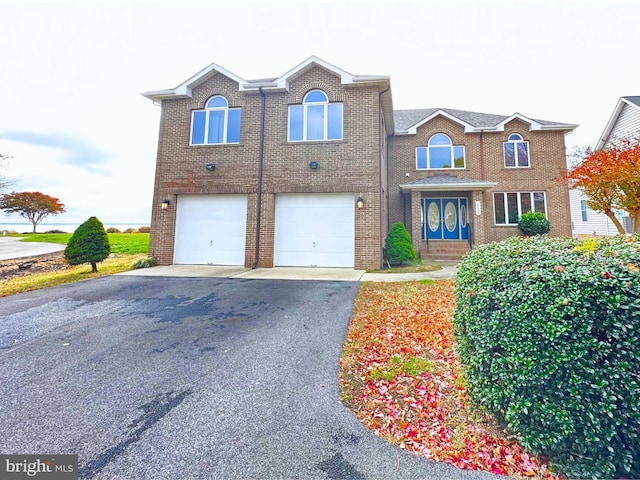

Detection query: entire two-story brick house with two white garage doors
xmin=144 ymin=57 xmax=576 ymax=269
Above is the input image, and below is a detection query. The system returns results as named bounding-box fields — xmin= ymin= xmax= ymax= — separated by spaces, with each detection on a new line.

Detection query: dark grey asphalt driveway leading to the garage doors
xmin=0 ymin=276 xmax=497 ymax=480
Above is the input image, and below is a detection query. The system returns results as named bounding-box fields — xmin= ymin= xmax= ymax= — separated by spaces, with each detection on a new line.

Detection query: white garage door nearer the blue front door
xmin=273 ymin=194 xmax=355 ymax=268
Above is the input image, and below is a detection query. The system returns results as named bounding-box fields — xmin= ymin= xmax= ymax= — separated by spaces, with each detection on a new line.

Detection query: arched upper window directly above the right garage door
xmin=289 ymin=90 xmax=342 ymax=142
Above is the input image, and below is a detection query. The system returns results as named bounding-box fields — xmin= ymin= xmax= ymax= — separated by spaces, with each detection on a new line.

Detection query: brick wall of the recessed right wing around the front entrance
xmin=389 ymin=116 xmax=571 ymax=253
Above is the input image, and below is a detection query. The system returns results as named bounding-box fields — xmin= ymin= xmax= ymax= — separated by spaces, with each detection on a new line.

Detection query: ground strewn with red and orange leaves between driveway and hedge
xmin=340 ymin=281 xmax=557 ymax=479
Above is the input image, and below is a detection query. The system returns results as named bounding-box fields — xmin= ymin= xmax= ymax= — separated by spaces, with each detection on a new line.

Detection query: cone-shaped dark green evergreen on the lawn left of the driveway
xmin=64 ymin=217 xmax=111 ymax=272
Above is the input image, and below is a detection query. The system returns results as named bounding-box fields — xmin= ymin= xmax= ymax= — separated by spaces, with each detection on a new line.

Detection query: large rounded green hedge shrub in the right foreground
xmin=454 ymin=236 xmax=640 ymax=478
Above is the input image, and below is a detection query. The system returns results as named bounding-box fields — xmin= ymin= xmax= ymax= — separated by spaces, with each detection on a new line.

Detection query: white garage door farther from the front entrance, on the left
xmin=173 ymin=195 xmax=247 ymax=265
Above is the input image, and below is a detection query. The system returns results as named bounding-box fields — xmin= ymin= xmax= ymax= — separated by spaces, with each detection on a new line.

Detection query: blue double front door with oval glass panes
xmin=422 ymin=198 xmax=469 ymax=240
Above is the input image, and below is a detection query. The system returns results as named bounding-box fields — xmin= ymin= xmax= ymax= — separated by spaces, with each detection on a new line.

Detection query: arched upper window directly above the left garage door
xmin=191 ymin=95 xmax=240 ymax=145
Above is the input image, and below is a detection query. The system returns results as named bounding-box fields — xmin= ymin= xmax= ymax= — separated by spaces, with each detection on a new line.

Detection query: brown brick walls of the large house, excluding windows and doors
xmin=145 ymin=57 xmax=571 ymax=269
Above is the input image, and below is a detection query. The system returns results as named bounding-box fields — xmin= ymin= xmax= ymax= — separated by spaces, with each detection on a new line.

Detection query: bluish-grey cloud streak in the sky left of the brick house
xmin=0 ymin=130 xmax=111 ymax=174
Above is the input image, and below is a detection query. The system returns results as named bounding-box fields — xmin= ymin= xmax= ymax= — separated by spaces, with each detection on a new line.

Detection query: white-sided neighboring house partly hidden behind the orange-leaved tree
xmin=569 ymin=96 xmax=640 ymax=237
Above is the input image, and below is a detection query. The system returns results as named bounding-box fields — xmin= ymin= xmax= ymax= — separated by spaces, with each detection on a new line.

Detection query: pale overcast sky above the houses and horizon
xmin=0 ymin=0 xmax=640 ymax=226
